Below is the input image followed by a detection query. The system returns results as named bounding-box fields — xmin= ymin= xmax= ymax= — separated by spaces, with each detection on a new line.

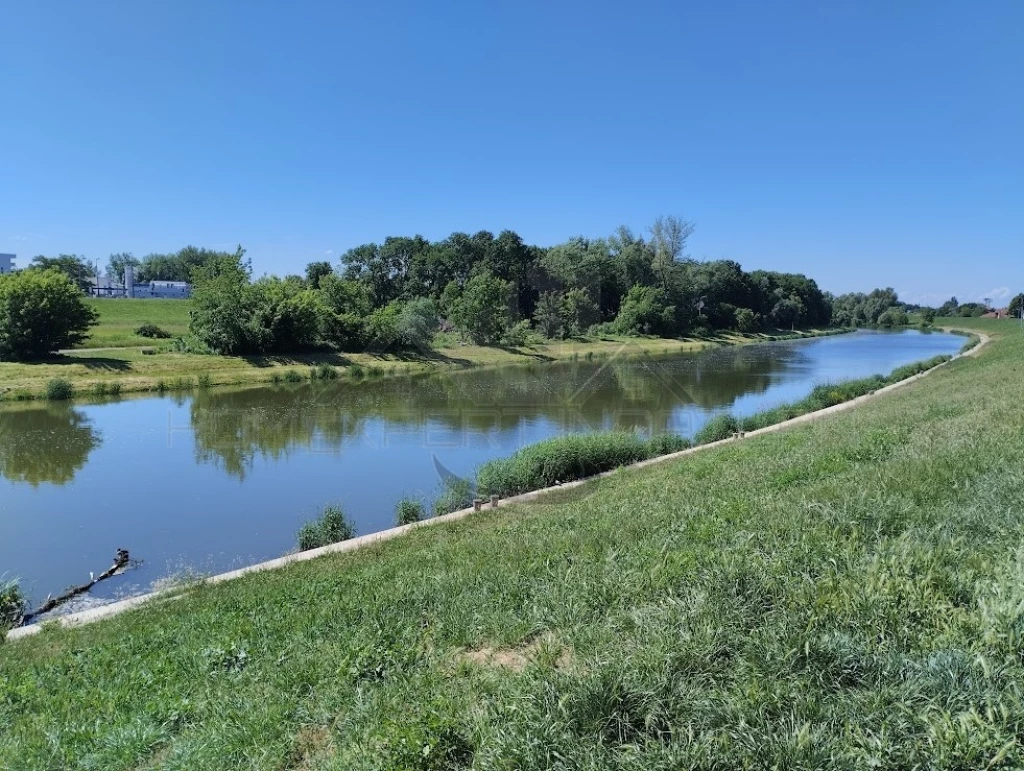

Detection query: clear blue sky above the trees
xmin=0 ymin=0 xmax=1024 ymax=302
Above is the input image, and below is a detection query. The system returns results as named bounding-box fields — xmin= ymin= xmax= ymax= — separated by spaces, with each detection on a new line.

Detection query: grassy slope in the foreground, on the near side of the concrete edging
xmin=0 ymin=322 xmax=1024 ymax=769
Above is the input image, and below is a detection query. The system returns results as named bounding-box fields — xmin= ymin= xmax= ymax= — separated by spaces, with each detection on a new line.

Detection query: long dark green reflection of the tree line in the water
xmin=190 ymin=347 xmax=801 ymax=478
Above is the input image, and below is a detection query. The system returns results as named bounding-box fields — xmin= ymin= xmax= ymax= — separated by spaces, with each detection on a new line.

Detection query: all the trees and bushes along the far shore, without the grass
xmin=0 ymin=217 xmax=1021 ymax=359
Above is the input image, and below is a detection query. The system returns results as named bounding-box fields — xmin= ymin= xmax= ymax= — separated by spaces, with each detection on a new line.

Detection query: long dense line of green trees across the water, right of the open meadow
xmin=190 ymin=217 xmax=831 ymax=354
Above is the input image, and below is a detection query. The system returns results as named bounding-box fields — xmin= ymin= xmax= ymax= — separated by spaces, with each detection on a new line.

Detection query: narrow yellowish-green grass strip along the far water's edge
xmin=0 ymin=325 xmax=843 ymax=401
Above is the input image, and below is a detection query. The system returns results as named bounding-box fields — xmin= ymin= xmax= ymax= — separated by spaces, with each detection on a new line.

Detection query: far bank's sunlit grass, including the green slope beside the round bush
xmin=0 ymin=299 xmax=836 ymax=401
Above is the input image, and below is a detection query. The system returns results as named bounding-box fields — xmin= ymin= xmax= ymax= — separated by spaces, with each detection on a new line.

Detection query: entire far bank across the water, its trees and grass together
xmin=0 ymin=225 xmax=928 ymax=400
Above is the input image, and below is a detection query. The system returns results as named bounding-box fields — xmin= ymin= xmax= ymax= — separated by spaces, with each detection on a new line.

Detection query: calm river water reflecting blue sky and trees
xmin=0 ymin=332 xmax=963 ymax=600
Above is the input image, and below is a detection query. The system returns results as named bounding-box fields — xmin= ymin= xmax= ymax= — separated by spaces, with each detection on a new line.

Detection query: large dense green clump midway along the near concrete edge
xmin=476 ymin=431 xmax=689 ymax=496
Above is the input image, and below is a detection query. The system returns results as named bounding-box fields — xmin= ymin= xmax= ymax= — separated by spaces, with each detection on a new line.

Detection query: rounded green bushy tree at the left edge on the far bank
xmin=0 ymin=268 xmax=98 ymax=360
